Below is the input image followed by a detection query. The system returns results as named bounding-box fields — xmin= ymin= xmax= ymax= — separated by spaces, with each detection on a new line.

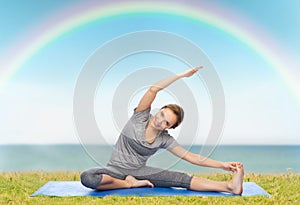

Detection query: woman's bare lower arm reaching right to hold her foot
xmin=171 ymin=145 xmax=240 ymax=172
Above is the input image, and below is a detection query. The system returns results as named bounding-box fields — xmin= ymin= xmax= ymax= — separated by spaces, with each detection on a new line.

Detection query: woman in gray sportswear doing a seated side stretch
xmin=81 ymin=66 xmax=244 ymax=194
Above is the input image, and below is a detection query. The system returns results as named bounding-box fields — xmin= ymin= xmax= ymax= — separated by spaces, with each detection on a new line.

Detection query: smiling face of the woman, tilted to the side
xmin=151 ymin=108 xmax=177 ymax=130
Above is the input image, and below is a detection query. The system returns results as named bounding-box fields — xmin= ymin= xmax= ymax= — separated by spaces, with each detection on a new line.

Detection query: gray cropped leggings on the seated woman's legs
xmin=80 ymin=166 xmax=192 ymax=189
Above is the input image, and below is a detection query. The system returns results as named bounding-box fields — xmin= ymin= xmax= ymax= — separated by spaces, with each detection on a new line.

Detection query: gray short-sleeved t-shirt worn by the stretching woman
xmin=107 ymin=108 xmax=178 ymax=169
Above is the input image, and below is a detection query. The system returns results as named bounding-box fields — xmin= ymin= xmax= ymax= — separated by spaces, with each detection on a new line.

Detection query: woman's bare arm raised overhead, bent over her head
xmin=136 ymin=66 xmax=203 ymax=111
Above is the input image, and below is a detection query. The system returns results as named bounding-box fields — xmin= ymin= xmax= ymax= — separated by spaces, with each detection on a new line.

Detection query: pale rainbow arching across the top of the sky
xmin=0 ymin=1 xmax=300 ymax=101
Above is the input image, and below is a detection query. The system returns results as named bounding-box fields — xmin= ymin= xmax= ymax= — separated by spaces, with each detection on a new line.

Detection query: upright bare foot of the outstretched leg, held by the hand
xmin=228 ymin=164 xmax=244 ymax=194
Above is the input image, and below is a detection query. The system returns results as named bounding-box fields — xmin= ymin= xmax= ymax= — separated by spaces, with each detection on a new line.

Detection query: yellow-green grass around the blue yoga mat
xmin=0 ymin=171 xmax=300 ymax=205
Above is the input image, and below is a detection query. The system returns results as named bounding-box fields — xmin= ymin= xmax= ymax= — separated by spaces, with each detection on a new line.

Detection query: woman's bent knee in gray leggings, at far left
xmin=80 ymin=169 xmax=102 ymax=189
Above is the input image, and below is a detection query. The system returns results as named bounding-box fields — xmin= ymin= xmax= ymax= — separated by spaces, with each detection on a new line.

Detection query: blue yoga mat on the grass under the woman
xmin=31 ymin=181 xmax=271 ymax=197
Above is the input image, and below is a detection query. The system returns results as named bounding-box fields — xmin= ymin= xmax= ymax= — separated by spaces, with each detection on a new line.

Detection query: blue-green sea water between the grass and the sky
xmin=0 ymin=145 xmax=300 ymax=174
